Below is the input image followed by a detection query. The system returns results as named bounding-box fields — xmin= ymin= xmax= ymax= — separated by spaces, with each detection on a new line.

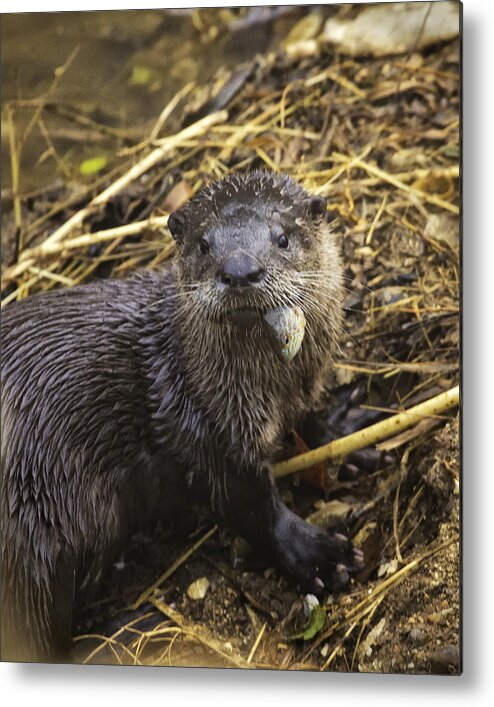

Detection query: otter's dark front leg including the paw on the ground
xmin=215 ymin=470 xmax=363 ymax=593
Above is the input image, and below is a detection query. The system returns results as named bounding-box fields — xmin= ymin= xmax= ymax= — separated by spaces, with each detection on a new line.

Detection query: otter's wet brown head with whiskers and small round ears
xmin=168 ymin=172 xmax=340 ymax=319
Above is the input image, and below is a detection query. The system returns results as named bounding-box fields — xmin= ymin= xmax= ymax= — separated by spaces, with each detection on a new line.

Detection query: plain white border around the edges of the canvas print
xmin=0 ymin=0 xmax=494 ymax=707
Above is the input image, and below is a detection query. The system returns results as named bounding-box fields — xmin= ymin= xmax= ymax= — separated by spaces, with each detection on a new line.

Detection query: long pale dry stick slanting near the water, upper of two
xmin=6 ymin=111 xmax=228 ymax=284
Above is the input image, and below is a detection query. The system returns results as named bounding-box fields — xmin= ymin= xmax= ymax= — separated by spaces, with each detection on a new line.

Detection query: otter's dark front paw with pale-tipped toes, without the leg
xmin=274 ymin=508 xmax=364 ymax=594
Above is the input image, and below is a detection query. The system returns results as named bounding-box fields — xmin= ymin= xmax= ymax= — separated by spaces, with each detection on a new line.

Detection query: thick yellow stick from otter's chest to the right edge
xmin=269 ymin=386 xmax=460 ymax=477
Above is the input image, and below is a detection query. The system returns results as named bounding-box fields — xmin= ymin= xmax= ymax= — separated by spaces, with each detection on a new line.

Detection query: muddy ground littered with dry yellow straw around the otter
xmin=2 ymin=8 xmax=461 ymax=674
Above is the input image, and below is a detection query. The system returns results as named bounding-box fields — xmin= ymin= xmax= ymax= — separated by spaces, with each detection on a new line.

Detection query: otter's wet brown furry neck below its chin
xmin=168 ymin=294 xmax=329 ymax=463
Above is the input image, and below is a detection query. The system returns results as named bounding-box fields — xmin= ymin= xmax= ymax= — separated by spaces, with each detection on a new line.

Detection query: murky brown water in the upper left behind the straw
xmin=1 ymin=8 xmax=294 ymax=195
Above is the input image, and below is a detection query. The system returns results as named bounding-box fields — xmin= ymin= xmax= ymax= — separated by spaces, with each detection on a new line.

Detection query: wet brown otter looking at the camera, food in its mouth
xmin=0 ymin=171 xmax=363 ymax=661
